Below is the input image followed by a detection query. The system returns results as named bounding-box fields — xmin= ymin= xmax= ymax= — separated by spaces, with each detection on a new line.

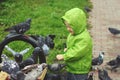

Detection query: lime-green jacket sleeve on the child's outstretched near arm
xmin=63 ymin=41 xmax=89 ymax=61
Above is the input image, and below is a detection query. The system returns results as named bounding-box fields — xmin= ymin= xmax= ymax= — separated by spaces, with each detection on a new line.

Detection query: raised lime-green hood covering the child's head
xmin=62 ymin=8 xmax=86 ymax=34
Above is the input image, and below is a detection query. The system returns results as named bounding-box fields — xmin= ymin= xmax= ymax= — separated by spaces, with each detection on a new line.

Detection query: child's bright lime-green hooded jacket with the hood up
xmin=62 ymin=8 xmax=93 ymax=74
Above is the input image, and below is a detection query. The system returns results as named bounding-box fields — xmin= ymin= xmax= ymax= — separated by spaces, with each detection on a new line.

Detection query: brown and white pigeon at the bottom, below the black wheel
xmin=15 ymin=63 xmax=47 ymax=80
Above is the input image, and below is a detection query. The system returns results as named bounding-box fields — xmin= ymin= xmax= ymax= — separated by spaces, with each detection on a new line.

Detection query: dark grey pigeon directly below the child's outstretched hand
xmin=48 ymin=63 xmax=66 ymax=73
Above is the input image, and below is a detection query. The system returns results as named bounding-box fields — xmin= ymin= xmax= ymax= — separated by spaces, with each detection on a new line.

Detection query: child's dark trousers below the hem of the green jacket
xmin=66 ymin=73 xmax=88 ymax=80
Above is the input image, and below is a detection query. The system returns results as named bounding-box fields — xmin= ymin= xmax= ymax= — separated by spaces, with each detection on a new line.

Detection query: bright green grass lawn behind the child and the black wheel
xmin=0 ymin=0 xmax=92 ymax=63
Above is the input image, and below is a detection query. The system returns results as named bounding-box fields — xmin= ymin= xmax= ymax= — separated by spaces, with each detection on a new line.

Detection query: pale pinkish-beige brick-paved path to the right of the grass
xmin=89 ymin=0 xmax=120 ymax=80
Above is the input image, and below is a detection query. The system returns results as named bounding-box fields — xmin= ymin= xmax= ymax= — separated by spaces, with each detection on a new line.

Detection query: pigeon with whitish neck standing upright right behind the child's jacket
xmin=92 ymin=52 xmax=104 ymax=66
